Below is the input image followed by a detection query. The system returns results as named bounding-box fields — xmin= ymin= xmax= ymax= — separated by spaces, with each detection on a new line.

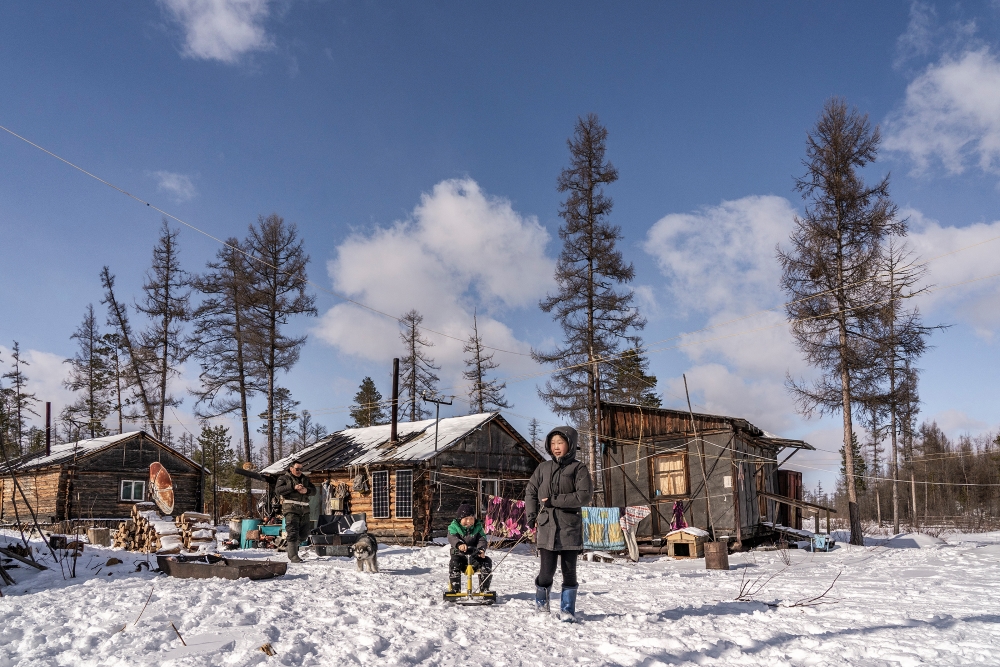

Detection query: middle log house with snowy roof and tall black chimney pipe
xmin=261 ymin=412 xmax=545 ymax=543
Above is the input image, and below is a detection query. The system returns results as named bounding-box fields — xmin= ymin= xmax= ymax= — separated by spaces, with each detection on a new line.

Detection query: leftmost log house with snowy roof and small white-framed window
xmin=0 ymin=431 xmax=203 ymax=523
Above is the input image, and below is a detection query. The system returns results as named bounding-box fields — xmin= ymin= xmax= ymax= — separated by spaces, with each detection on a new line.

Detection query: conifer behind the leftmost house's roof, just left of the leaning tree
xmin=63 ymin=305 xmax=114 ymax=438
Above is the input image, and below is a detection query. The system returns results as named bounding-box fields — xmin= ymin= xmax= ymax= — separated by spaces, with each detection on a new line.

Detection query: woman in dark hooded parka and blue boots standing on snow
xmin=524 ymin=426 xmax=593 ymax=621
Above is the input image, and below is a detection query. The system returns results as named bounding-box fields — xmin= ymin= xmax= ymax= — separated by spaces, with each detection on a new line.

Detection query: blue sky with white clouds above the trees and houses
xmin=0 ymin=0 xmax=1000 ymax=485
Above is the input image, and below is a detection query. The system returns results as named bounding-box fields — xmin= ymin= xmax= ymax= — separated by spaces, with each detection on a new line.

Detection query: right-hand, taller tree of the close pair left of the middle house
xmin=243 ymin=213 xmax=316 ymax=463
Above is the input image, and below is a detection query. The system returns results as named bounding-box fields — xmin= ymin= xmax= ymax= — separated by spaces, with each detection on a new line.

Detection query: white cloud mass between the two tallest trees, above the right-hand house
xmin=645 ymin=196 xmax=811 ymax=432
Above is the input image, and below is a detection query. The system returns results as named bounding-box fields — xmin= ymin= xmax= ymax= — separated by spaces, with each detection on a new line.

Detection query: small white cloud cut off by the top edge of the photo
xmin=160 ymin=0 xmax=272 ymax=64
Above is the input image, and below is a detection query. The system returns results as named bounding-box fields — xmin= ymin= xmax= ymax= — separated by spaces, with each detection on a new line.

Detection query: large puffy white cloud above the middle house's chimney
xmin=317 ymin=179 xmax=554 ymax=380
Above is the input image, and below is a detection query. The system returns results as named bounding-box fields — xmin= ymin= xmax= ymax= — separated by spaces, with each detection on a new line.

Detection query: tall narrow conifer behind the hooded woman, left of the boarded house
xmin=532 ymin=114 xmax=646 ymax=489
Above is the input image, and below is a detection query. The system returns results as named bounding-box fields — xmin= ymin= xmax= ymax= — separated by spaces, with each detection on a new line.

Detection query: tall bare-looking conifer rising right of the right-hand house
xmin=778 ymin=98 xmax=906 ymax=545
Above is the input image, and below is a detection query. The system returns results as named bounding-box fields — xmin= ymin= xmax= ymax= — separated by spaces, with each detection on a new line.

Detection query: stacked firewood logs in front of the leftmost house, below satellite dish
xmin=114 ymin=502 xmax=211 ymax=554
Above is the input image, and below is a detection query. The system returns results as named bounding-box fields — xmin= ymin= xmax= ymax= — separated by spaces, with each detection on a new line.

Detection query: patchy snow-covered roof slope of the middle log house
xmin=261 ymin=412 xmax=534 ymax=475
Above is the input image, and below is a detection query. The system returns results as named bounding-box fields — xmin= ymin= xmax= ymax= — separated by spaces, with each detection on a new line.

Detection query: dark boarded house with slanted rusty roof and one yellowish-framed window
xmin=600 ymin=403 xmax=813 ymax=544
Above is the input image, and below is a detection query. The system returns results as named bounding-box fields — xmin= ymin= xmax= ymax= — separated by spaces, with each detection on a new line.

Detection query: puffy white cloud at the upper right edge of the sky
xmin=885 ymin=47 xmax=1000 ymax=174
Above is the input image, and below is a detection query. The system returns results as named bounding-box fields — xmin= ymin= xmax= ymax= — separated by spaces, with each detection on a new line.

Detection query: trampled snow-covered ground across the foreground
xmin=0 ymin=533 xmax=1000 ymax=667
